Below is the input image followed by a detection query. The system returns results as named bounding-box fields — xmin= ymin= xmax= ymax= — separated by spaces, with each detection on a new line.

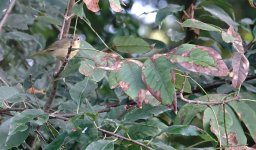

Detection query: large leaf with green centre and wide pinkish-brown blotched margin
xmin=169 ymin=44 xmax=229 ymax=76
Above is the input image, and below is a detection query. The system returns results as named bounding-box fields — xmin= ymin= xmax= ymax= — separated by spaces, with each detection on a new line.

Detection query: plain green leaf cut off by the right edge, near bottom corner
xmin=229 ymin=102 xmax=256 ymax=143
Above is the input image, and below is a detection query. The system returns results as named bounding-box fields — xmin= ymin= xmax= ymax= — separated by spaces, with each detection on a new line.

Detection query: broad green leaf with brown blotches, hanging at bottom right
xmin=203 ymin=105 xmax=246 ymax=146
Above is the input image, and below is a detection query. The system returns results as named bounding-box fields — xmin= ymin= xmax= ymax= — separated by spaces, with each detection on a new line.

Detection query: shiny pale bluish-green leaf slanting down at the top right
xmin=203 ymin=5 xmax=237 ymax=27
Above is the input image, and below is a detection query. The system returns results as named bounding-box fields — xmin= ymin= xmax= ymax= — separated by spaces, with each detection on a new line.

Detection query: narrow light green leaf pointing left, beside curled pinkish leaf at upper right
xmin=181 ymin=19 xmax=222 ymax=32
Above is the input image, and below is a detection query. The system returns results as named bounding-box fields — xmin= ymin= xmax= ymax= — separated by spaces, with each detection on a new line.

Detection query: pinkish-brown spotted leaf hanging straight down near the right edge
xmin=232 ymin=52 xmax=249 ymax=88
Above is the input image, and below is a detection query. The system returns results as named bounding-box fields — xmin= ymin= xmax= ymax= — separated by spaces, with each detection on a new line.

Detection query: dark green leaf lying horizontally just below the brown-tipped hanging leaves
xmin=123 ymin=105 xmax=169 ymax=122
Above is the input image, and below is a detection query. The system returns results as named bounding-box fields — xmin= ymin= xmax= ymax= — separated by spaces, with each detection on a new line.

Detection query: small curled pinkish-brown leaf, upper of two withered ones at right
xmin=227 ymin=26 xmax=244 ymax=53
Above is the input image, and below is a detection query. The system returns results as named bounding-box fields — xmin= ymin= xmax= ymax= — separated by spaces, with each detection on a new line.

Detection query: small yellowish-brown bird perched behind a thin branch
xmin=32 ymin=36 xmax=81 ymax=61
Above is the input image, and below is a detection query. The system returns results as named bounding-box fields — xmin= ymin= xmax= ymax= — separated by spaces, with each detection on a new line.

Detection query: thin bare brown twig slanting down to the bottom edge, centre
xmin=98 ymin=128 xmax=153 ymax=150
